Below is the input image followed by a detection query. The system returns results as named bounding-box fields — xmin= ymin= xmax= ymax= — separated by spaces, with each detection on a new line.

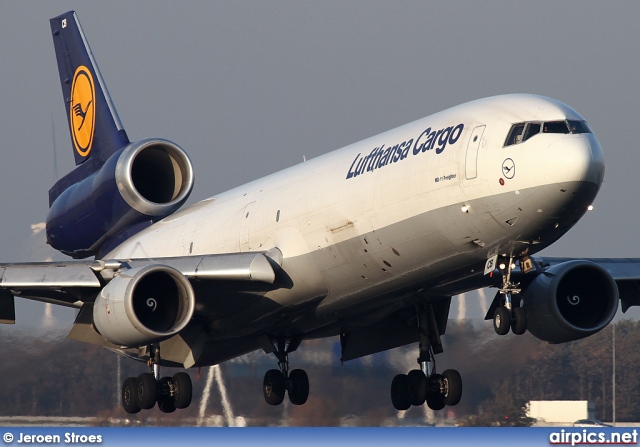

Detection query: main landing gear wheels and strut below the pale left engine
xmin=122 ymin=345 xmax=192 ymax=414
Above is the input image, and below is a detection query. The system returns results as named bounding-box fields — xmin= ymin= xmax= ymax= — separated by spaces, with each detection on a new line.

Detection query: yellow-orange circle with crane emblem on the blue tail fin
xmin=69 ymin=65 xmax=96 ymax=157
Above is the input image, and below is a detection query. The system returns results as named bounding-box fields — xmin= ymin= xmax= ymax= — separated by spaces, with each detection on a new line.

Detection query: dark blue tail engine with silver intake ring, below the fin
xmin=46 ymin=139 xmax=193 ymax=258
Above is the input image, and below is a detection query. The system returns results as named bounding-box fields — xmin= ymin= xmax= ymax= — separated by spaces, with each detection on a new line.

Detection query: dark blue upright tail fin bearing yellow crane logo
xmin=50 ymin=11 xmax=129 ymax=166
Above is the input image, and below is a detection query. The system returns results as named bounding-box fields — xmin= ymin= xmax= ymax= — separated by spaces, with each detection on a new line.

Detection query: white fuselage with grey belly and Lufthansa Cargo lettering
xmin=105 ymin=95 xmax=604 ymax=336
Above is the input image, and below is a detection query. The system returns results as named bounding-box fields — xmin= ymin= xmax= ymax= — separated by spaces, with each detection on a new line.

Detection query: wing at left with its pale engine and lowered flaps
xmin=0 ymin=249 xmax=282 ymax=366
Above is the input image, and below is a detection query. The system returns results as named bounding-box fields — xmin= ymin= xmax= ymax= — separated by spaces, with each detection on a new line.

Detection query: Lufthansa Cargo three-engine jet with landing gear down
xmin=0 ymin=12 xmax=640 ymax=413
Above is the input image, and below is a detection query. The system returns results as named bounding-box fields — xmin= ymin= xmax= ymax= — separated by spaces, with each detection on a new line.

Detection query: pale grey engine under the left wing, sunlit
xmin=93 ymin=265 xmax=195 ymax=347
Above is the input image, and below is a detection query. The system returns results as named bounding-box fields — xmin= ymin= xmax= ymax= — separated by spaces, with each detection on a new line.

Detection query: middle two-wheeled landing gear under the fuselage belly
xmin=262 ymin=337 xmax=309 ymax=405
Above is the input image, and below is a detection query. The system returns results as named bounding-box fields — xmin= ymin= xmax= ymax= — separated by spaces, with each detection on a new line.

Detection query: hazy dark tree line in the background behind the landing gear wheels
xmin=0 ymin=320 xmax=640 ymax=426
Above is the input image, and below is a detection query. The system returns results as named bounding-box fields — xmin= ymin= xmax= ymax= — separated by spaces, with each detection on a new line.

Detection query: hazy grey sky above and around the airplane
xmin=0 ymin=0 xmax=640 ymax=328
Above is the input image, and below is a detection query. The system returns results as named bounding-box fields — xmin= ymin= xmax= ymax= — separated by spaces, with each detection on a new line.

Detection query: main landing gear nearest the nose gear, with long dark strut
xmin=391 ymin=304 xmax=462 ymax=410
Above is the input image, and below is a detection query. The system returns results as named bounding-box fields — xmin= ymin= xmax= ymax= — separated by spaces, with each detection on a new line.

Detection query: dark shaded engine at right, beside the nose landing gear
xmin=522 ymin=261 xmax=618 ymax=343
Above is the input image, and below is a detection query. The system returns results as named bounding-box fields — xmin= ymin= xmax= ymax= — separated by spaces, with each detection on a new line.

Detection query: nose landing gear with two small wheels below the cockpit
xmin=493 ymin=258 xmax=527 ymax=335
